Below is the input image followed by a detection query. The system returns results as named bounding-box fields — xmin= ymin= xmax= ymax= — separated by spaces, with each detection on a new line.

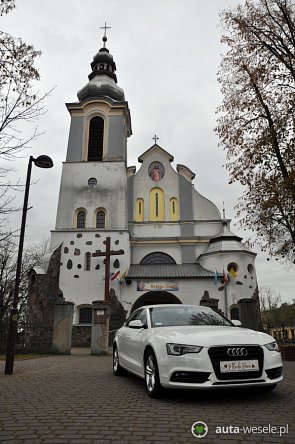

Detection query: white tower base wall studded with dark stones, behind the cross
xmin=51 ymin=230 xmax=130 ymax=305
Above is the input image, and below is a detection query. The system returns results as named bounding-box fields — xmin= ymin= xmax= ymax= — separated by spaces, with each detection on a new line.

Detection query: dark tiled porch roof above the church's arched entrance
xmin=126 ymin=264 xmax=214 ymax=279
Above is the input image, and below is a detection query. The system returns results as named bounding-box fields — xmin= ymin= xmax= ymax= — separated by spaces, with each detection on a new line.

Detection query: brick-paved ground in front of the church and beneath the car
xmin=0 ymin=350 xmax=295 ymax=444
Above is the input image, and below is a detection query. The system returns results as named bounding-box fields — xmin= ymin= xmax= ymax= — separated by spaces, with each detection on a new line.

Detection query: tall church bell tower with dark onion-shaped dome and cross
xmin=51 ymin=25 xmax=132 ymax=312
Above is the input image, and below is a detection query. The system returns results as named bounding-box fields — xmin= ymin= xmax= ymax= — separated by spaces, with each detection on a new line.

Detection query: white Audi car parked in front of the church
xmin=113 ymin=304 xmax=283 ymax=397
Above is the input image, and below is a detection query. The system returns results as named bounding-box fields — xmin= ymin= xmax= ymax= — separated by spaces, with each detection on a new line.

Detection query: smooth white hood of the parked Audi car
xmin=150 ymin=325 xmax=274 ymax=347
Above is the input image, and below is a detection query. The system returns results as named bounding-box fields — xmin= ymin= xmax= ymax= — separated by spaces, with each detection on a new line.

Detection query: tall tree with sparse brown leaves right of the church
xmin=216 ymin=0 xmax=295 ymax=262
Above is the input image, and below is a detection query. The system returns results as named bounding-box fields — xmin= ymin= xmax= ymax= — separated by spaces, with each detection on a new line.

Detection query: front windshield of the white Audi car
xmin=150 ymin=306 xmax=233 ymax=327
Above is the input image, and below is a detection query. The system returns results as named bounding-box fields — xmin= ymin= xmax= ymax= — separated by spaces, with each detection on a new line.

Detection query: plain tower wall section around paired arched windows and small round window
xmin=56 ymin=162 xmax=127 ymax=229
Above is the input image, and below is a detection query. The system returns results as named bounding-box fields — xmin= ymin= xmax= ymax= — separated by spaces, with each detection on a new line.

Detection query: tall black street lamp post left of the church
xmin=5 ymin=155 xmax=53 ymax=375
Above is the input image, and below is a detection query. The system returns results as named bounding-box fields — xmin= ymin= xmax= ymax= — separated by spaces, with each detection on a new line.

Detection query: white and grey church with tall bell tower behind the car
xmin=28 ymin=36 xmax=257 ymax=346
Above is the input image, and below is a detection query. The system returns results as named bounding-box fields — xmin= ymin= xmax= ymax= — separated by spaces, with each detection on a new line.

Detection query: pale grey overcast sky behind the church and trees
xmin=0 ymin=0 xmax=295 ymax=301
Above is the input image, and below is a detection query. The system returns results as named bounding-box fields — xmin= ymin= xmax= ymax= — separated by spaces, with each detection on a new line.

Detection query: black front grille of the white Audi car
xmin=208 ymin=345 xmax=263 ymax=381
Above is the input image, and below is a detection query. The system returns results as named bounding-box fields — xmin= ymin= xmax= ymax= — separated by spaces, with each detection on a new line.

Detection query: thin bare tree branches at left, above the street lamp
xmin=0 ymin=0 xmax=51 ymax=236
